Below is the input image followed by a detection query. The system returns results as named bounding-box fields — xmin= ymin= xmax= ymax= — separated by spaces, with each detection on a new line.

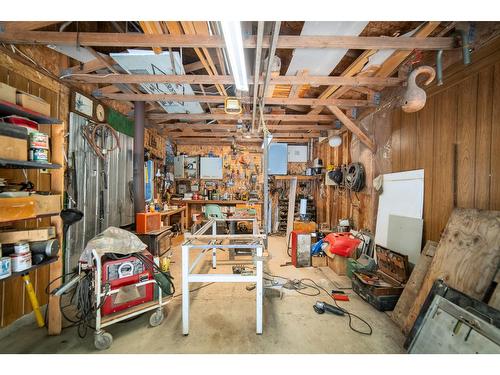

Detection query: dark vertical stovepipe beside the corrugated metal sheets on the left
xmin=134 ymin=102 xmax=145 ymax=214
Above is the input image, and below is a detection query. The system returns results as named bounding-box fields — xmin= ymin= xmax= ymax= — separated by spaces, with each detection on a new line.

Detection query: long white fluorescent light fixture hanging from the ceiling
xmin=221 ymin=21 xmax=248 ymax=91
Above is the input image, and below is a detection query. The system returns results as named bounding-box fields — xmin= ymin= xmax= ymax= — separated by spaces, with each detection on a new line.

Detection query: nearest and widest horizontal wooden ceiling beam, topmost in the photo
xmin=0 ymin=31 xmax=454 ymax=51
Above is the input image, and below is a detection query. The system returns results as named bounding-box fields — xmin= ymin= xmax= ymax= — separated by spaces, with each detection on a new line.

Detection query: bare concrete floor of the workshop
xmin=0 ymin=237 xmax=404 ymax=353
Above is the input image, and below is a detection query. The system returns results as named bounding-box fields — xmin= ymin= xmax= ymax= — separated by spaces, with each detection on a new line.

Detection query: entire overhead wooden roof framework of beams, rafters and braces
xmin=0 ymin=21 xmax=455 ymax=151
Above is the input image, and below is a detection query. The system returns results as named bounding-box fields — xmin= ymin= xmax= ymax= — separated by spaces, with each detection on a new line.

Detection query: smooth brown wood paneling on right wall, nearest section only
xmin=391 ymin=39 xmax=500 ymax=241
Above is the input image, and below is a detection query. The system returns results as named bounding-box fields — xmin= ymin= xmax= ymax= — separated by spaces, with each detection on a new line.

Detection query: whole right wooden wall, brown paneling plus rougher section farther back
xmin=317 ymin=38 xmax=500 ymax=244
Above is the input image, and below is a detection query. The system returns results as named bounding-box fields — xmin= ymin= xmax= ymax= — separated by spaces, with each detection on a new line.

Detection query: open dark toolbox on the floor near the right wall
xmin=352 ymin=245 xmax=408 ymax=311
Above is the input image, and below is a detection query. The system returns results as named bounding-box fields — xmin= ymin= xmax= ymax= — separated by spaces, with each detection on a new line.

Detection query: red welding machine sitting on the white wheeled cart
xmin=101 ymin=253 xmax=154 ymax=316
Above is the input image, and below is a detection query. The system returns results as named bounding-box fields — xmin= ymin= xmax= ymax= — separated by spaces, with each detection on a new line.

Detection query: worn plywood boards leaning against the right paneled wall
xmin=392 ymin=208 xmax=500 ymax=334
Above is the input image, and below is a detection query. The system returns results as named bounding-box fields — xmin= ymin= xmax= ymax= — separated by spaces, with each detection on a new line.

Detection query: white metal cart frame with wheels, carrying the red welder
xmin=92 ymin=250 xmax=171 ymax=350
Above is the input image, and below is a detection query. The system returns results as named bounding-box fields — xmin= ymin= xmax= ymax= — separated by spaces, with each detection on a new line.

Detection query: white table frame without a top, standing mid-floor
xmin=181 ymin=218 xmax=266 ymax=335
